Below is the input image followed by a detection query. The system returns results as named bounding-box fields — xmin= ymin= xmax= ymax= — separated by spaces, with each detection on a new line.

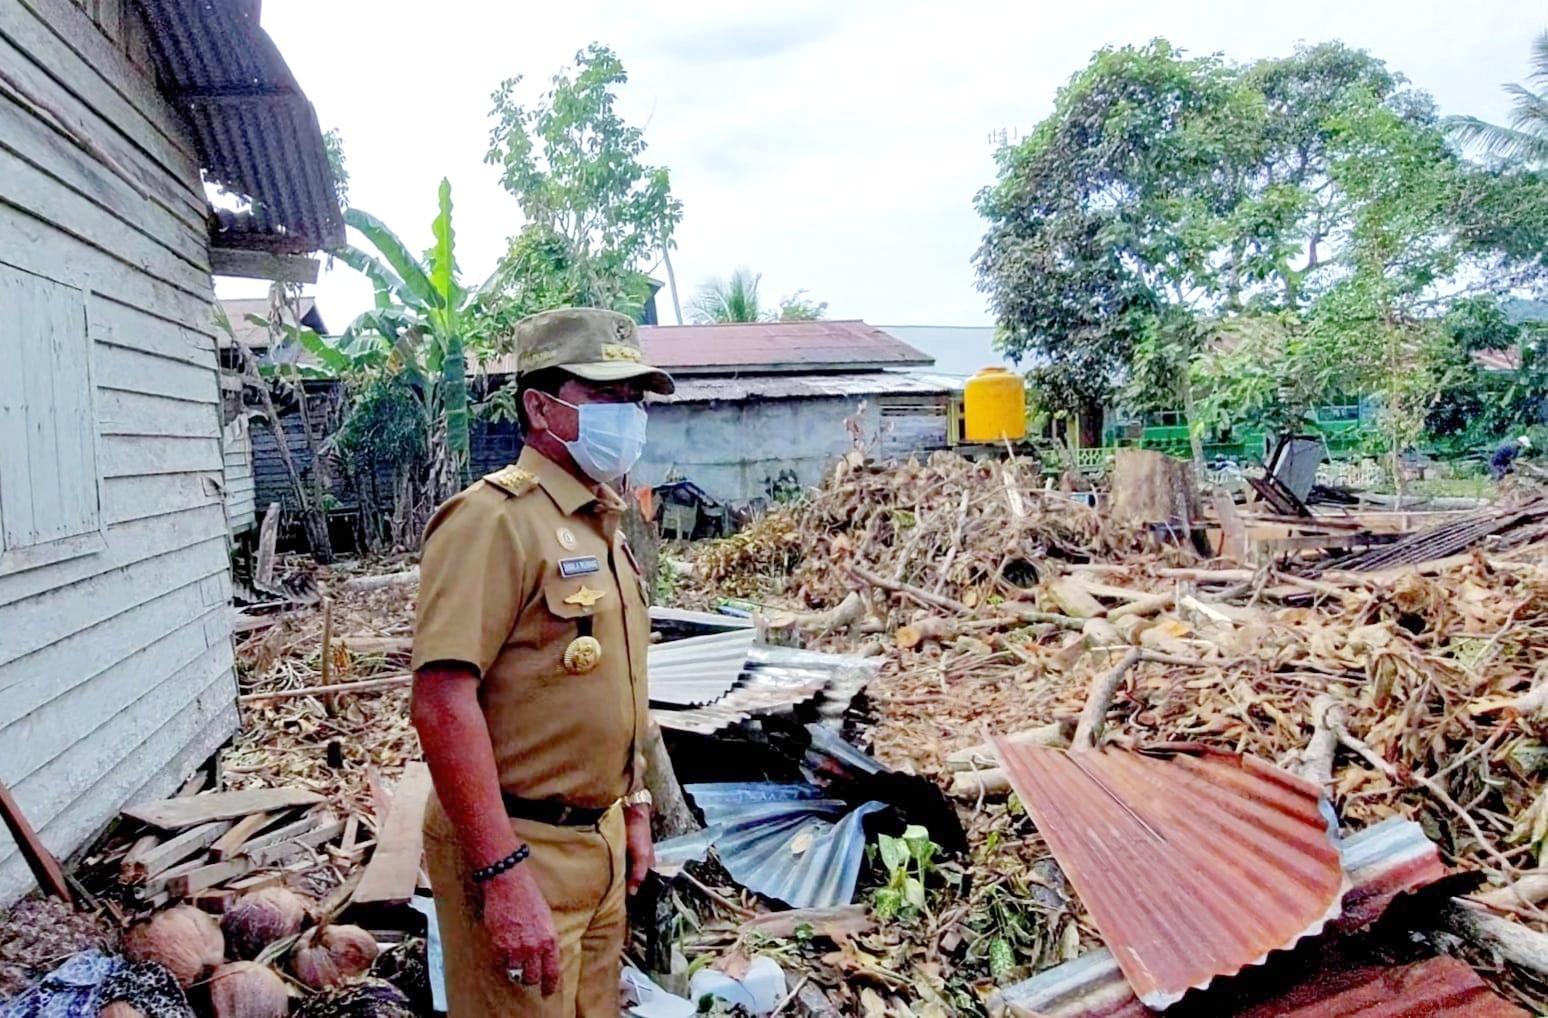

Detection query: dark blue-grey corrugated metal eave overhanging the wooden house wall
xmin=139 ymin=0 xmax=344 ymax=254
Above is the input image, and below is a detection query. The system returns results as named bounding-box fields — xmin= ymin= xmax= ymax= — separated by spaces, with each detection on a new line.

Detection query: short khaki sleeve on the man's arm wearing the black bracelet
xmin=412 ymin=494 xmax=526 ymax=678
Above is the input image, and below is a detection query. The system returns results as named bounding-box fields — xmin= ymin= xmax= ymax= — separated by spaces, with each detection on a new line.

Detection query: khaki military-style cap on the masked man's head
xmin=515 ymin=308 xmax=676 ymax=395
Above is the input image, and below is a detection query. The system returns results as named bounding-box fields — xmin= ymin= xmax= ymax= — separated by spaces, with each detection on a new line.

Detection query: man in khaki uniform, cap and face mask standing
xmin=413 ymin=308 xmax=672 ymax=1018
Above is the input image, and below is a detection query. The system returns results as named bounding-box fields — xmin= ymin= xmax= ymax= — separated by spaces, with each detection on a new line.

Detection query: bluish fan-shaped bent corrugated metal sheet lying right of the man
xmin=671 ymin=781 xmax=887 ymax=908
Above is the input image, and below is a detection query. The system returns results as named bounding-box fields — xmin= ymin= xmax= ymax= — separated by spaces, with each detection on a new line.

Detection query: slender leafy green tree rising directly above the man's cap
xmin=488 ymin=43 xmax=683 ymax=319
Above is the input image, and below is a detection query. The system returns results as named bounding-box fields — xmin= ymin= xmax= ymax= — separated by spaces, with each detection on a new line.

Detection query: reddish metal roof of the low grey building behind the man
xmin=485 ymin=320 xmax=933 ymax=374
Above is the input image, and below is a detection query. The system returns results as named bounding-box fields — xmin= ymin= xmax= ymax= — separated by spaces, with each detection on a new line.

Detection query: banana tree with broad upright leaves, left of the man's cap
xmin=334 ymin=179 xmax=495 ymax=503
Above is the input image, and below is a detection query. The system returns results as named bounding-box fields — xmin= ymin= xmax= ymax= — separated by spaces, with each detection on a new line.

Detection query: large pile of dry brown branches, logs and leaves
xmin=680 ymin=455 xmax=1548 ymax=1013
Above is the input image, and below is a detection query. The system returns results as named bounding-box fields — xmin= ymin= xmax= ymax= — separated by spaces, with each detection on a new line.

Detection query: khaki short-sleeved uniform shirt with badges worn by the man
xmin=413 ymin=447 xmax=650 ymax=808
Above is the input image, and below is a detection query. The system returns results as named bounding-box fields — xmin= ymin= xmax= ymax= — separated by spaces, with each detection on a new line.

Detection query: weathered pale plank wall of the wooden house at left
xmin=0 ymin=0 xmax=237 ymax=904
